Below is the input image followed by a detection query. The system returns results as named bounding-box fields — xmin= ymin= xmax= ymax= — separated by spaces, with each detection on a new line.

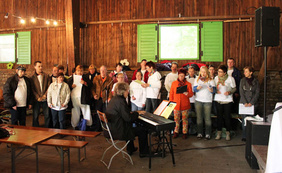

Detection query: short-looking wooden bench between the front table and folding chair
xmin=40 ymin=139 xmax=88 ymax=173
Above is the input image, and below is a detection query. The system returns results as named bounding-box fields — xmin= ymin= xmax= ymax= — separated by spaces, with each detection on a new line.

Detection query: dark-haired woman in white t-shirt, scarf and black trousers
xmin=214 ymin=65 xmax=236 ymax=141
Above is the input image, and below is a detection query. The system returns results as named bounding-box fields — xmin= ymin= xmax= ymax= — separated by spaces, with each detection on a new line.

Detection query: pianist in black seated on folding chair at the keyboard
xmin=105 ymin=82 xmax=149 ymax=157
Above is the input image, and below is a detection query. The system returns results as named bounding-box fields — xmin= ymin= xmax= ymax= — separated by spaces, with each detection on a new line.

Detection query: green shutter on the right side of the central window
xmin=201 ymin=22 xmax=223 ymax=62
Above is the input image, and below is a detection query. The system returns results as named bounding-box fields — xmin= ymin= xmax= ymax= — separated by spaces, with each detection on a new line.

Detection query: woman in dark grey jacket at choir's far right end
xmin=239 ymin=66 xmax=259 ymax=141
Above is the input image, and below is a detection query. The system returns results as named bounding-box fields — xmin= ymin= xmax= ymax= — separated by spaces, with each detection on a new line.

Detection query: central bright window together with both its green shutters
xmin=137 ymin=22 xmax=223 ymax=62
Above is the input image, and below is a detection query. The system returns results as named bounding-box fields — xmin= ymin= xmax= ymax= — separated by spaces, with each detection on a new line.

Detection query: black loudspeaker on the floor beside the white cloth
xmin=245 ymin=121 xmax=270 ymax=169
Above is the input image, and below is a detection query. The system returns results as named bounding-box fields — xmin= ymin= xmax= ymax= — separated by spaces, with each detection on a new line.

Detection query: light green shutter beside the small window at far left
xmin=17 ymin=31 xmax=31 ymax=64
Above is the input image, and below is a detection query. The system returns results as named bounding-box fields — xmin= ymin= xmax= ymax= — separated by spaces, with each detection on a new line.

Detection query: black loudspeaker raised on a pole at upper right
xmin=255 ymin=7 xmax=280 ymax=47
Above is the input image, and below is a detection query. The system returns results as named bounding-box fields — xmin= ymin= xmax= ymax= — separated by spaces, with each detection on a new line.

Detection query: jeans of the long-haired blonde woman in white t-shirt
xmin=195 ymin=101 xmax=212 ymax=135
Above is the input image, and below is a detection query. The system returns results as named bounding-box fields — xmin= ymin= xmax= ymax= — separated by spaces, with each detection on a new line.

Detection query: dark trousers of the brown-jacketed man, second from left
xmin=32 ymin=101 xmax=50 ymax=128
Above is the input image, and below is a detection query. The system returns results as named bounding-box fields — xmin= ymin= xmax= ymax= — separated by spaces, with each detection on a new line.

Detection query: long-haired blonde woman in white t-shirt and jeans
xmin=193 ymin=66 xmax=216 ymax=140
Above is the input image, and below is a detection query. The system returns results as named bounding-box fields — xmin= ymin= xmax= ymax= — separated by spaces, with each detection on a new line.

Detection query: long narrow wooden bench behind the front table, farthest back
xmin=0 ymin=125 xmax=101 ymax=162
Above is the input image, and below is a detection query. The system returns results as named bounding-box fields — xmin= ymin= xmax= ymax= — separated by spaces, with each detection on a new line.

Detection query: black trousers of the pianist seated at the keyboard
xmin=127 ymin=126 xmax=149 ymax=154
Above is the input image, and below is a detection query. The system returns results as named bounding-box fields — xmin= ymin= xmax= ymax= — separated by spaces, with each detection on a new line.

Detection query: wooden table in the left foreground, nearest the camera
xmin=0 ymin=126 xmax=58 ymax=173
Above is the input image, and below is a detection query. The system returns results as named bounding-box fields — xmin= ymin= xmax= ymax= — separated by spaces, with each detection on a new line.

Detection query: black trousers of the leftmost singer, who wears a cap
xmin=10 ymin=107 xmax=26 ymax=126
